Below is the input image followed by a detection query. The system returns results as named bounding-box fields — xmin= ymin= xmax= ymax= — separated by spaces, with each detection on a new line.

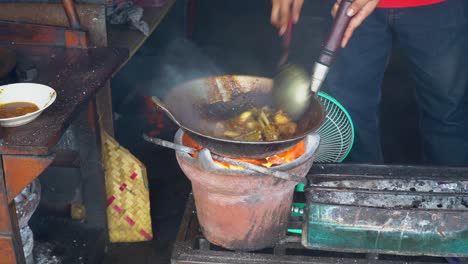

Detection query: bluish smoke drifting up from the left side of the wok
xmin=112 ymin=32 xmax=227 ymax=113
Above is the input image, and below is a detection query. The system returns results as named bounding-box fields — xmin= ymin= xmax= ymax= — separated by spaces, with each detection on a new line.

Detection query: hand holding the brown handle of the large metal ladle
xmin=331 ymin=0 xmax=380 ymax=48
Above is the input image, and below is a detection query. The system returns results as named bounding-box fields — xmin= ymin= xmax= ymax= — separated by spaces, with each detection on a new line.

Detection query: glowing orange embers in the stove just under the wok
xmin=182 ymin=134 xmax=305 ymax=170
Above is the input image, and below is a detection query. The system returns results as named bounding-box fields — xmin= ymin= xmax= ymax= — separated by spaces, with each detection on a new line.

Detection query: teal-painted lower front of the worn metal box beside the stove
xmin=302 ymin=202 xmax=468 ymax=258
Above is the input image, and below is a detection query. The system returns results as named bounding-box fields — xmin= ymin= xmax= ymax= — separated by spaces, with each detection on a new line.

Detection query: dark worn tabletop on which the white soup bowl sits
xmin=0 ymin=46 xmax=127 ymax=155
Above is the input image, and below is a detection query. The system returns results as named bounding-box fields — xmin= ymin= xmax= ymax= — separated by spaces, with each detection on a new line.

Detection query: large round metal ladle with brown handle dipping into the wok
xmin=273 ymin=0 xmax=354 ymax=119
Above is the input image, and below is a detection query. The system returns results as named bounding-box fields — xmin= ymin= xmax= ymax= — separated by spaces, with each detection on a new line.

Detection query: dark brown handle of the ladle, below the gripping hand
xmin=317 ymin=0 xmax=354 ymax=67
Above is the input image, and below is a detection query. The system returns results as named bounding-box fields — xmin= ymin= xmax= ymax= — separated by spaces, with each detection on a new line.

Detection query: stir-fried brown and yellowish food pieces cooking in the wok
xmin=216 ymin=106 xmax=297 ymax=142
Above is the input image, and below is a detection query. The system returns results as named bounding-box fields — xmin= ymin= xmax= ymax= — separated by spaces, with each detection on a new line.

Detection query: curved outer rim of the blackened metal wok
xmin=163 ymin=74 xmax=326 ymax=145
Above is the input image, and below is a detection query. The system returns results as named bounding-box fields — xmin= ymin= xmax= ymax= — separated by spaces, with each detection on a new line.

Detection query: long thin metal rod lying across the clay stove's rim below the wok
xmin=143 ymin=135 xmax=307 ymax=184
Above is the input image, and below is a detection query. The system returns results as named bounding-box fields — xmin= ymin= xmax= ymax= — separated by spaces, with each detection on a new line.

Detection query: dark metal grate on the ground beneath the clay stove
xmin=171 ymin=195 xmax=458 ymax=264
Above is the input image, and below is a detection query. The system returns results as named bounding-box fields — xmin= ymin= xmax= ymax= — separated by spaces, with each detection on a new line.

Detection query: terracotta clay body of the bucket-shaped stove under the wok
xmin=174 ymin=130 xmax=320 ymax=251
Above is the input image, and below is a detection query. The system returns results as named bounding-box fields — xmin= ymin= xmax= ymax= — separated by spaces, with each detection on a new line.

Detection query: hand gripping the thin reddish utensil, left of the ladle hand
xmin=271 ymin=0 xmax=304 ymax=36
